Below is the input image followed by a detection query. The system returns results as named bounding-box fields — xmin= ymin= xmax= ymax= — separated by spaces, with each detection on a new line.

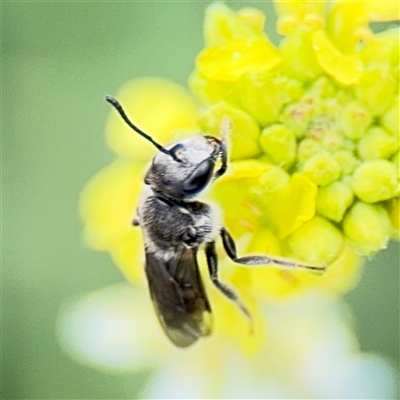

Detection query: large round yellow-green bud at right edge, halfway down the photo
xmin=352 ymin=160 xmax=399 ymax=203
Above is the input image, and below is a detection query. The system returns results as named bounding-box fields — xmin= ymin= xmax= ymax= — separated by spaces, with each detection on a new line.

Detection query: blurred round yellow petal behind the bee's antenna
xmin=106 ymin=78 xmax=197 ymax=161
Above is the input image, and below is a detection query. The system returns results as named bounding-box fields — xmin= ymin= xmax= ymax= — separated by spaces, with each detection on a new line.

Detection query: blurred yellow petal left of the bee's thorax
xmin=80 ymin=160 xmax=144 ymax=282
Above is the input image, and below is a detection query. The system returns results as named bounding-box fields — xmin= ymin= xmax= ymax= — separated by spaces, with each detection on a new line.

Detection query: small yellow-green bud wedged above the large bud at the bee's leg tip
xmin=317 ymin=181 xmax=354 ymax=222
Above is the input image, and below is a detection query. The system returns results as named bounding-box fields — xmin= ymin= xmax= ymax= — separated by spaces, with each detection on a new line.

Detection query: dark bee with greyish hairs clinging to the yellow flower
xmin=106 ymin=96 xmax=325 ymax=347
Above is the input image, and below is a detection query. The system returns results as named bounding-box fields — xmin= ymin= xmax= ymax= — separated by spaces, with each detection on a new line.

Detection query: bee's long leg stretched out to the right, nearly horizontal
xmin=221 ymin=228 xmax=326 ymax=272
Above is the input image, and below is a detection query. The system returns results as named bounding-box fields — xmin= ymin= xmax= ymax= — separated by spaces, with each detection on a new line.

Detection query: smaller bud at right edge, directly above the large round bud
xmin=357 ymin=127 xmax=399 ymax=160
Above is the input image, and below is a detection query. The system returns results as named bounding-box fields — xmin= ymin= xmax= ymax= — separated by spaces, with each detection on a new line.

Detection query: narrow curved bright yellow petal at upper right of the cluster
xmin=313 ymin=31 xmax=362 ymax=85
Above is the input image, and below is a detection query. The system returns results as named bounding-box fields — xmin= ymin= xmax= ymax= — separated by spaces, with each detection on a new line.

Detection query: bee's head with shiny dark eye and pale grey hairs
xmin=145 ymin=135 xmax=221 ymax=200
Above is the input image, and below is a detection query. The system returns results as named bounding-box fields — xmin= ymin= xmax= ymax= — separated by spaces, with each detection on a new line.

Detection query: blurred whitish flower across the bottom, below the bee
xmin=58 ymin=284 xmax=396 ymax=399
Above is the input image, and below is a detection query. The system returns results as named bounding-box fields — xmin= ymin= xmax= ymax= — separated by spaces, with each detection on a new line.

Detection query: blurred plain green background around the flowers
xmin=2 ymin=1 xmax=399 ymax=399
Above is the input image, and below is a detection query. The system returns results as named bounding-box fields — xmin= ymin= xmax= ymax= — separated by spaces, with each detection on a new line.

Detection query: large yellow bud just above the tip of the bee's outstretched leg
xmin=287 ymin=216 xmax=344 ymax=265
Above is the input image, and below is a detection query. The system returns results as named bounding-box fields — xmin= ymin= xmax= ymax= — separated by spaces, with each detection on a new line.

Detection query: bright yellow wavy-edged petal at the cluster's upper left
xmin=196 ymin=38 xmax=280 ymax=82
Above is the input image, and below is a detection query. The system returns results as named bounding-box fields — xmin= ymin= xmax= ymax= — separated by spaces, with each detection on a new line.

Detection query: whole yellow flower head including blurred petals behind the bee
xmin=81 ymin=1 xmax=399 ymax=353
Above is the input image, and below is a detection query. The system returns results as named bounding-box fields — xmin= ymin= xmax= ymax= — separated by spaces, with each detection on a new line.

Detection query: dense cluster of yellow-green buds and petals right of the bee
xmin=190 ymin=1 xmax=399 ymax=293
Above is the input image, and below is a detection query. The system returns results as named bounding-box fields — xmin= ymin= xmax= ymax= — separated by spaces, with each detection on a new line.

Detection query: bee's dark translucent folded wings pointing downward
xmin=146 ymin=249 xmax=211 ymax=347
